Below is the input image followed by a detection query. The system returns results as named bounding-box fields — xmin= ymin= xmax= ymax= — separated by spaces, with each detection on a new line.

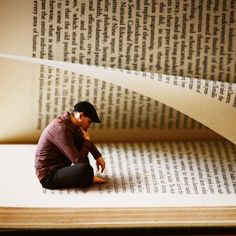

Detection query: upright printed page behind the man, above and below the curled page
xmin=0 ymin=0 xmax=235 ymax=142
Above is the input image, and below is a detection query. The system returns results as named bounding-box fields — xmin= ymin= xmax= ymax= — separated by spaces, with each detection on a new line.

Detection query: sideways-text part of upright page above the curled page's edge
xmin=0 ymin=0 xmax=236 ymax=82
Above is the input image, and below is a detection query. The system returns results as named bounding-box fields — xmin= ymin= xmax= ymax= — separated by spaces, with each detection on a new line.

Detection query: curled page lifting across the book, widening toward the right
xmin=0 ymin=54 xmax=236 ymax=144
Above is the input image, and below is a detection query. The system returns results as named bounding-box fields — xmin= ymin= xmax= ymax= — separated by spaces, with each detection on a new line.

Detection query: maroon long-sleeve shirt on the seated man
xmin=35 ymin=112 xmax=101 ymax=180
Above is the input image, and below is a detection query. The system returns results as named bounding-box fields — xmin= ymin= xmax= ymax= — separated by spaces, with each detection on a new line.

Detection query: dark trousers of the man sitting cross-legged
xmin=40 ymin=162 xmax=94 ymax=189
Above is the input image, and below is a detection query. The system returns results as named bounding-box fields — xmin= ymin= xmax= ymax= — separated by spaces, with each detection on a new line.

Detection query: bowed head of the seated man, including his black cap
xmin=73 ymin=101 xmax=101 ymax=130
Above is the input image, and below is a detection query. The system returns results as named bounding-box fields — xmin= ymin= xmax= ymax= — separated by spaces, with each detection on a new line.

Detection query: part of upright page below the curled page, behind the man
xmin=0 ymin=54 xmax=223 ymax=143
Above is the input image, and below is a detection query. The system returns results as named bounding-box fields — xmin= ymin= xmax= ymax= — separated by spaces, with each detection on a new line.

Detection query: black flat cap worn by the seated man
xmin=74 ymin=101 xmax=101 ymax=123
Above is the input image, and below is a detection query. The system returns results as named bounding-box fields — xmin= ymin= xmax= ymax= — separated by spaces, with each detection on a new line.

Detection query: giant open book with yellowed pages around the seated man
xmin=0 ymin=0 xmax=236 ymax=228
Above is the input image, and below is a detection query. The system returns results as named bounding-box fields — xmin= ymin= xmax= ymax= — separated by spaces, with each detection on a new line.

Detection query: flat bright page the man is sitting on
xmin=0 ymin=141 xmax=236 ymax=208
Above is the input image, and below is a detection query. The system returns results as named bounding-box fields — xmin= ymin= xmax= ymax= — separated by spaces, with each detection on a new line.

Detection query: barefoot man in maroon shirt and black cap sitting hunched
xmin=35 ymin=101 xmax=105 ymax=189
